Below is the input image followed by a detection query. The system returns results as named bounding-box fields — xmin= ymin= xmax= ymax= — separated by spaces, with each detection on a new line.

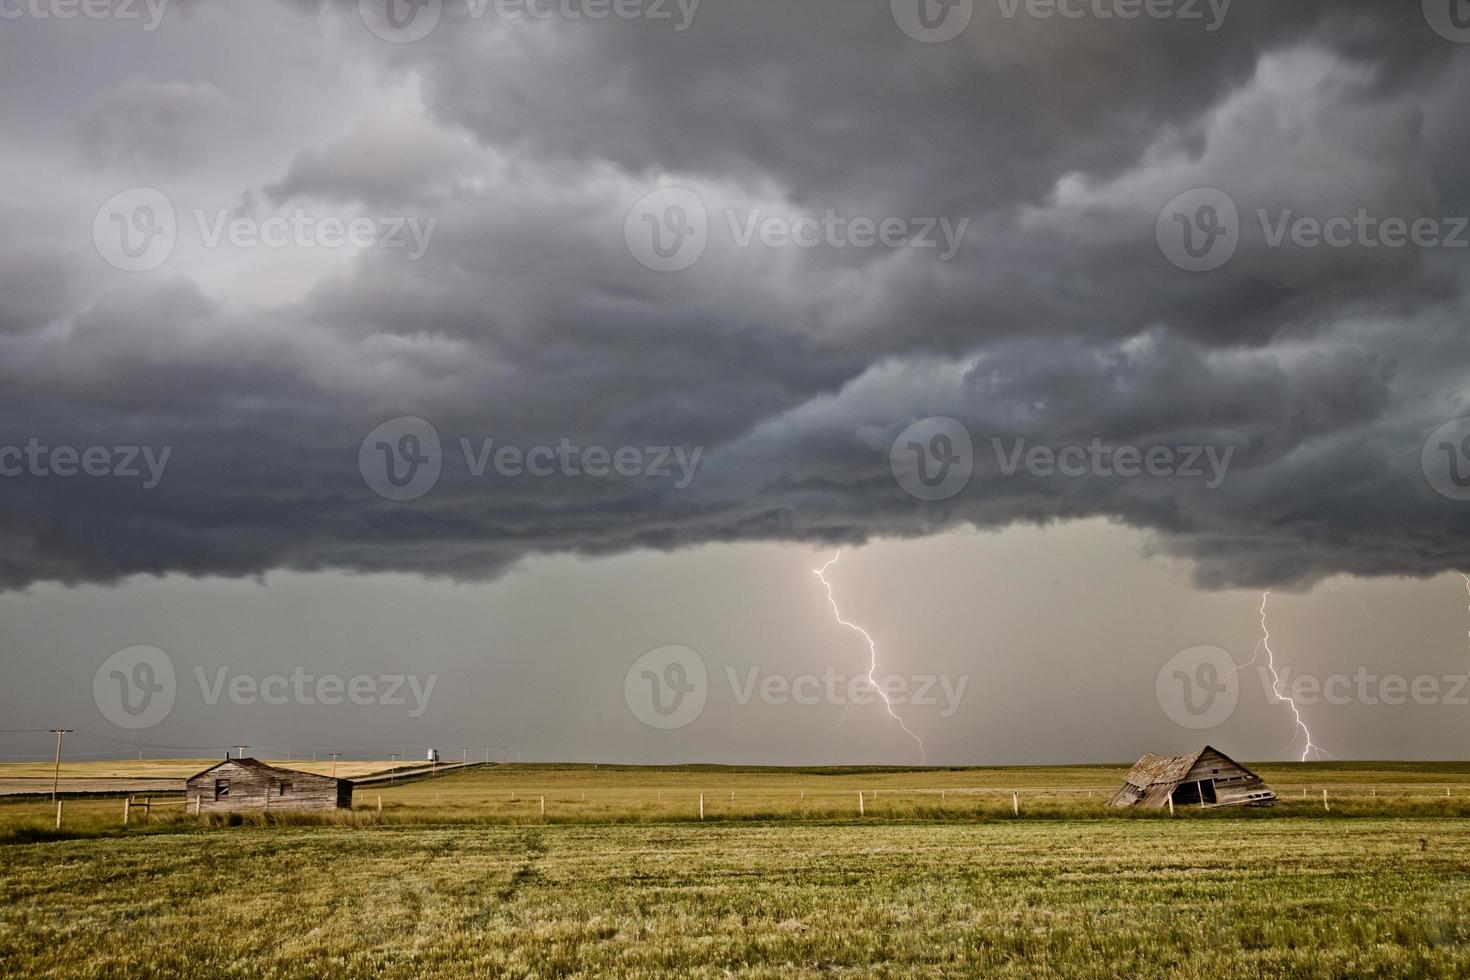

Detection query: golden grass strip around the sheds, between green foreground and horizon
xmin=0 ymin=763 xmax=1470 ymax=842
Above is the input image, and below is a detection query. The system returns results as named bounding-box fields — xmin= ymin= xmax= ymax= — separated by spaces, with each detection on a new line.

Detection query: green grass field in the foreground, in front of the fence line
xmin=0 ymin=818 xmax=1470 ymax=979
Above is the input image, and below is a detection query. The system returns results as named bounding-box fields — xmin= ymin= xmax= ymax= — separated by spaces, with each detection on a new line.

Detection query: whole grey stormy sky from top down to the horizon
xmin=0 ymin=0 xmax=1470 ymax=763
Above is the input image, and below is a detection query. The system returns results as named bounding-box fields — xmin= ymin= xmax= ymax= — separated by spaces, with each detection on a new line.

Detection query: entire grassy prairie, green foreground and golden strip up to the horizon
xmin=0 ymin=764 xmax=1470 ymax=977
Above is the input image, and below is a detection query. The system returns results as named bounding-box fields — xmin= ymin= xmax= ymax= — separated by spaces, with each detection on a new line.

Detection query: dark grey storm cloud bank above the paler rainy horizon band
xmin=0 ymin=0 xmax=1470 ymax=588
